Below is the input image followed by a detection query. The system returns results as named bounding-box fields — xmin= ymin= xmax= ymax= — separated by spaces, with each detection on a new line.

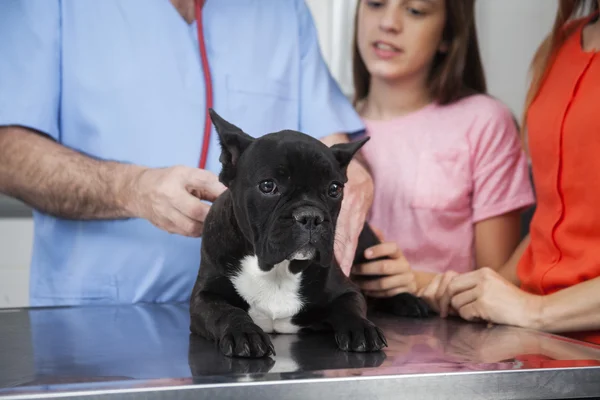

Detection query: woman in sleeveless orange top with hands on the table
xmin=424 ymin=0 xmax=600 ymax=343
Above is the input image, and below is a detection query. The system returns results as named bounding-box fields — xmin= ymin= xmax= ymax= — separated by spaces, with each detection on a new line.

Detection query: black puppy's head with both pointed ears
xmin=210 ymin=109 xmax=368 ymax=271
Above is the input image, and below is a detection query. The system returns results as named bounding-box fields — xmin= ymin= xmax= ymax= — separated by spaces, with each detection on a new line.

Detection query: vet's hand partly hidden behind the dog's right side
xmin=334 ymin=160 xmax=373 ymax=276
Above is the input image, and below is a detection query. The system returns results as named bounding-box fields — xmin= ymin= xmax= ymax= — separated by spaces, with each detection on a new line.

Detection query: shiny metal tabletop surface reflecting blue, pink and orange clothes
xmin=0 ymin=304 xmax=600 ymax=396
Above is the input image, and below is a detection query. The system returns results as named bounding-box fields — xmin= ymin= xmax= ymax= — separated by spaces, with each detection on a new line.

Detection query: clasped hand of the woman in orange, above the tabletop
xmin=448 ymin=268 xmax=542 ymax=328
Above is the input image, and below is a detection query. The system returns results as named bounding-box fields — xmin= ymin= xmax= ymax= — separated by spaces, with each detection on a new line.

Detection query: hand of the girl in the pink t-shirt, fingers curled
xmin=352 ymin=232 xmax=417 ymax=297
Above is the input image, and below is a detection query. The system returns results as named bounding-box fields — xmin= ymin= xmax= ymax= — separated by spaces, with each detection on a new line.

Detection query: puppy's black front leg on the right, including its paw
xmin=327 ymin=292 xmax=387 ymax=352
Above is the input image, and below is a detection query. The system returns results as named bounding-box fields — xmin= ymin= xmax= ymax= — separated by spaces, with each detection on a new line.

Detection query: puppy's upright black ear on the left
xmin=208 ymin=108 xmax=254 ymax=186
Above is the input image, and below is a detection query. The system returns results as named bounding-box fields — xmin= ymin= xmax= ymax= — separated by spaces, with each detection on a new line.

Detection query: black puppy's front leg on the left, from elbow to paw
xmin=190 ymin=292 xmax=275 ymax=358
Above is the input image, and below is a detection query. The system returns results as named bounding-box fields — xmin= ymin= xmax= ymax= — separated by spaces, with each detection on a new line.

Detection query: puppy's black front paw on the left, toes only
xmin=219 ymin=324 xmax=275 ymax=358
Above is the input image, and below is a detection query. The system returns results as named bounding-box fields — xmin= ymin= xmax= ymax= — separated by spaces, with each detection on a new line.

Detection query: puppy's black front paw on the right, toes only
xmin=335 ymin=318 xmax=387 ymax=352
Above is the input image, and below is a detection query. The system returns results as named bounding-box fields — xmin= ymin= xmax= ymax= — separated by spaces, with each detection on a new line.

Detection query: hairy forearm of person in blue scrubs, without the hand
xmin=0 ymin=127 xmax=143 ymax=219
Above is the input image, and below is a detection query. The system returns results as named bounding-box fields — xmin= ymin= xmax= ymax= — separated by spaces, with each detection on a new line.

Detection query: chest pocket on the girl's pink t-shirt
xmin=409 ymin=150 xmax=471 ymax=210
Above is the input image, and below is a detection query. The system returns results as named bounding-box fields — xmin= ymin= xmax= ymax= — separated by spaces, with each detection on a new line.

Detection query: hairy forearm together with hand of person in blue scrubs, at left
xmin=0 ymin=126 xmax=224 ymax=236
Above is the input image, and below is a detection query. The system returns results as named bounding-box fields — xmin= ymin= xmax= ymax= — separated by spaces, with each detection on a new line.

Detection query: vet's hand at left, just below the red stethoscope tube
xmin=131 ymin=166 xmax=225 ymax=237
